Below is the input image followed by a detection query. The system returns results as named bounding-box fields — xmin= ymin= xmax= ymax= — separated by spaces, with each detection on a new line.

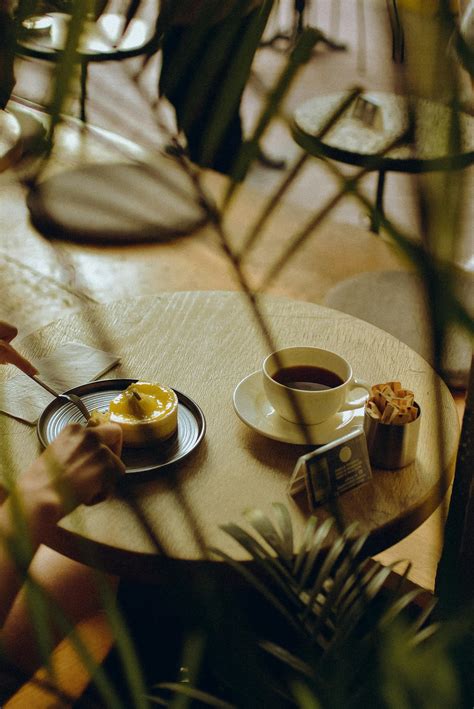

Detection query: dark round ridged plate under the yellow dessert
xmin=37 ymin=379 xmax=206 ymax=475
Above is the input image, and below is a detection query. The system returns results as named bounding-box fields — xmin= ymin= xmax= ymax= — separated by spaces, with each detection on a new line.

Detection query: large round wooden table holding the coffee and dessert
xmin=0 ymin=292 xmax=459 ymax=578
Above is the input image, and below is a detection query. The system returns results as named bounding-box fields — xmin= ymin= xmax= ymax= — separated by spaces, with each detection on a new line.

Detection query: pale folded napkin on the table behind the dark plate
xmin=0 ymin=342 xmax=120 ymax=424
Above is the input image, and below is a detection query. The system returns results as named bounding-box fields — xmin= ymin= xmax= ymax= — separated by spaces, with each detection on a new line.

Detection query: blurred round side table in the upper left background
xmin=16 ymin=12 xmax=154 ymax=122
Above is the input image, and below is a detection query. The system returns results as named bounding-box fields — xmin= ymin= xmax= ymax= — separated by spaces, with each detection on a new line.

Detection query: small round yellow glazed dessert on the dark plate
xmin=90 ymin=382 xmax=178 ymax=447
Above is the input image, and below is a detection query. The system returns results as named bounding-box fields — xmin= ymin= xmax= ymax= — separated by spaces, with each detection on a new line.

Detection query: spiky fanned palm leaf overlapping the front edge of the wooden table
xmin=217 ymin=506 xmax=442 ymax=672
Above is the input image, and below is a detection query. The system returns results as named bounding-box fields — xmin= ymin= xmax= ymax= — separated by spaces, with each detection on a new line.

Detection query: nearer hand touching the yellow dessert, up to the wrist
xmin=17 ymin=423 xmax=125 ymax=542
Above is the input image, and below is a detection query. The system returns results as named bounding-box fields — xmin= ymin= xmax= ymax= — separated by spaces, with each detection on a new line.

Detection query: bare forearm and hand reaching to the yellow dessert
xmin=0 ymin=424 xmax=124 ymax=627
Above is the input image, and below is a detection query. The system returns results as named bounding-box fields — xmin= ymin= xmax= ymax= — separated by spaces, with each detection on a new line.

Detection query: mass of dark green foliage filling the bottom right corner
xmin=151 ymin=504 xmax=474 ymax=709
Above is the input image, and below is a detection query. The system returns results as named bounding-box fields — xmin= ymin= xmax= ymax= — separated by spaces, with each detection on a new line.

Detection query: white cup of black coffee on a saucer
xmin=263 ymin=347 xmax=370 ymax=425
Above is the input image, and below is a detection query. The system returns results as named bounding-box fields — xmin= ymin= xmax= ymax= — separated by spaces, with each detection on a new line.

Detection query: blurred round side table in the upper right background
xmin=293 ymin=92 xmax=474 ymax=233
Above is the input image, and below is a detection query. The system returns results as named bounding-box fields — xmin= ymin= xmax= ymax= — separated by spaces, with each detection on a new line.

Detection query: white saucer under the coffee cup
xmin=233 ymin=370 xmax=364 ymax=446
